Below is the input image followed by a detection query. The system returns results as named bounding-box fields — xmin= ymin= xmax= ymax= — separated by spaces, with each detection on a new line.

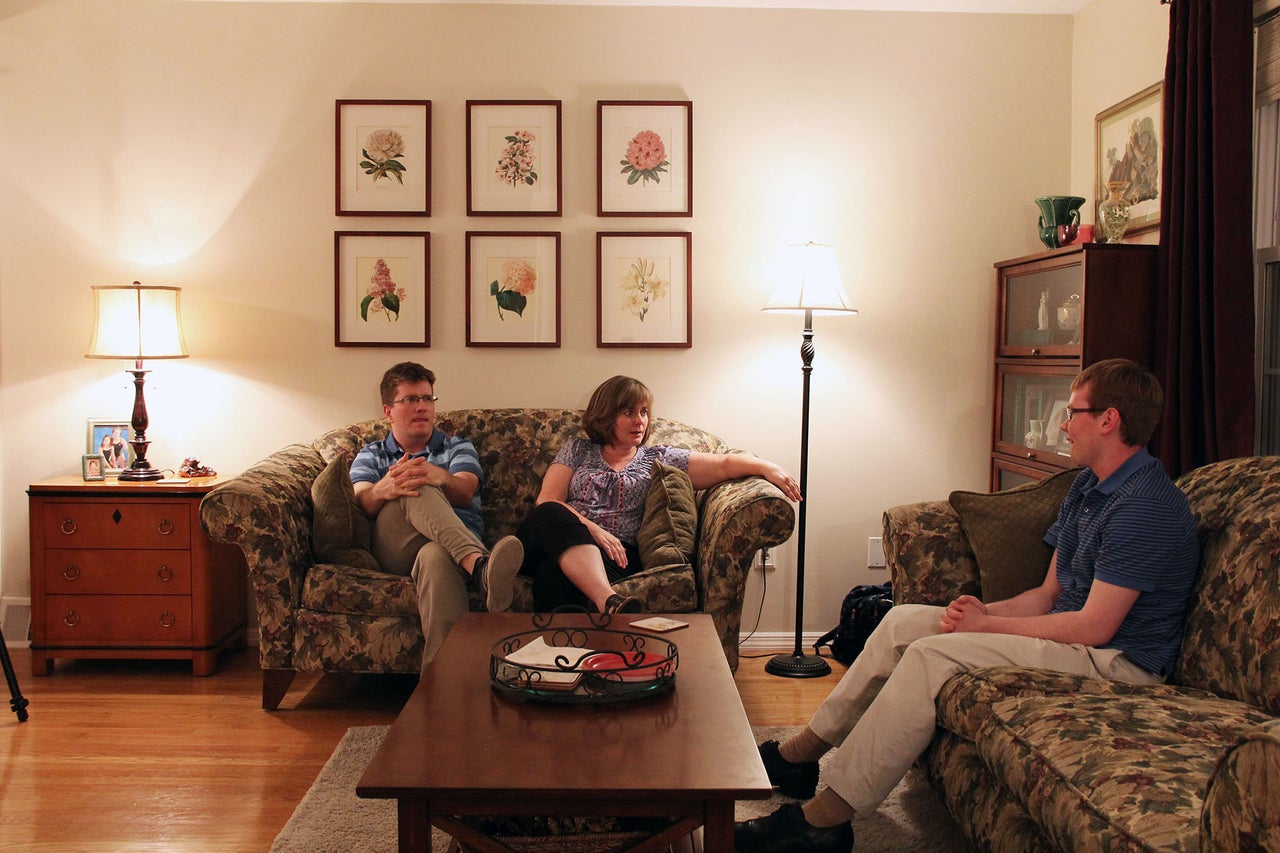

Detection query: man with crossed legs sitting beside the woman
xmin=351 ymin=361 xmax=525 ymax=670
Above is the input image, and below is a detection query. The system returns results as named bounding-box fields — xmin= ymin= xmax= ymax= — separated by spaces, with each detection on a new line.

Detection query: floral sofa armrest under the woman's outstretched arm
xmin=696 ymin=476 xmax=796 ymax=669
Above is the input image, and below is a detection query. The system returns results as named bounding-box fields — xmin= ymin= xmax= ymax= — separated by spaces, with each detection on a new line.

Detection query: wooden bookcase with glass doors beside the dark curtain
xmin=991 ymin=243 xmax=1157 ymax=491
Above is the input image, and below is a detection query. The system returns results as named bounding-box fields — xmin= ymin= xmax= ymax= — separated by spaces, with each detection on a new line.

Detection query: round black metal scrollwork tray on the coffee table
xmin=489 ymin=611 xmax=680 ymax=704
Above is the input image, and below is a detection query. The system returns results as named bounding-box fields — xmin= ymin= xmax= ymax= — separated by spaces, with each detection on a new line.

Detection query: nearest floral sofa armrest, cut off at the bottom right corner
xmin=1199 ymin=720 xmax=1280 ymax=850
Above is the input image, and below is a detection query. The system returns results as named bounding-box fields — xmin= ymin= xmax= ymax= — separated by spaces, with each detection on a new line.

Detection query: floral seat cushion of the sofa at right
xmin=977 ymin=692 xmax=1268 ymax=850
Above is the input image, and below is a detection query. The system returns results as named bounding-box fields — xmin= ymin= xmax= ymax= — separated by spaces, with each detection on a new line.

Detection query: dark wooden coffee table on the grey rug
xmin=356 ymin=613 xmax=771 ymax=853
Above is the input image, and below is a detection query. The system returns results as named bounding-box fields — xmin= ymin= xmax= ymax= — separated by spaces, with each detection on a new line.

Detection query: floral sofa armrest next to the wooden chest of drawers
xmin=200 ymin=444 xmax=324 ymax=669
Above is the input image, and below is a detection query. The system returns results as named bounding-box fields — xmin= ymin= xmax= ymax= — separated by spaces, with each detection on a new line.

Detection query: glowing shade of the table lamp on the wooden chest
xmin=84 ymin=282 xmax=187 ymax=361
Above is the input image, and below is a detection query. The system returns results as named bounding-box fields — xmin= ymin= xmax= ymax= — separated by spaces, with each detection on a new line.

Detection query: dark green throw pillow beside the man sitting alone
xmin=948 ymin=469 xmax=1080 ymax=602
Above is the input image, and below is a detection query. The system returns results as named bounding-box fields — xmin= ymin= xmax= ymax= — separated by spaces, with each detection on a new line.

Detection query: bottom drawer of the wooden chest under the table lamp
xmin=45 ymin=596 xmax=192 ymax=646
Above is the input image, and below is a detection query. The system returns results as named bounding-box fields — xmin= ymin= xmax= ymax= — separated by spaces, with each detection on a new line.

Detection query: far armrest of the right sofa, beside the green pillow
xmin=883 ymin=501 xmax=982 ymax=605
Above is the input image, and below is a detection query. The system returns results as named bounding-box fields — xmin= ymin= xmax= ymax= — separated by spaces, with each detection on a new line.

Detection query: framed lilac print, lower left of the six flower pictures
xmin=333 ymin=231 xmax=431 ymax=347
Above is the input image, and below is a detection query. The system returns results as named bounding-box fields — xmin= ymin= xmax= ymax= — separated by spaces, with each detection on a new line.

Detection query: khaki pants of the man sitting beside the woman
xmin=374 ymin=485 xmax=486 ymax=670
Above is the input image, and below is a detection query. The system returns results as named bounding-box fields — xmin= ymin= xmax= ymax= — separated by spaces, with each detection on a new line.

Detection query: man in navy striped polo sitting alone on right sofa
xmin=735 ymin=359 xmax=1199 ymax=853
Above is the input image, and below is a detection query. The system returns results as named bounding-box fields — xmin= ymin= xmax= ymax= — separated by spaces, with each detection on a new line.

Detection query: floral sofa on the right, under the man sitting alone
xmin=884 ymin=457 xmax=1280 ymax=853
